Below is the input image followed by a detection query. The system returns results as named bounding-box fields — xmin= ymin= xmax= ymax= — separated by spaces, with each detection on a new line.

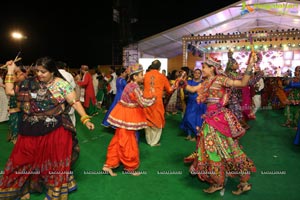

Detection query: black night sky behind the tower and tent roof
xmin=0 ymin=0 xmax=237 ymax=68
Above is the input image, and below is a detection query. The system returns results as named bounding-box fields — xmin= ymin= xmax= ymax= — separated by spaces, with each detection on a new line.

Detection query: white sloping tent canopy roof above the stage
xmin=130 ymin=0 xmax=300 ymax=58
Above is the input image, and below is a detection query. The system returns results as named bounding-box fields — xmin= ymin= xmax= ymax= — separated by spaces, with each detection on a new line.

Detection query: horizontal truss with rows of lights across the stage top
xmin=183 ymin=28 xmax=300 ymax=52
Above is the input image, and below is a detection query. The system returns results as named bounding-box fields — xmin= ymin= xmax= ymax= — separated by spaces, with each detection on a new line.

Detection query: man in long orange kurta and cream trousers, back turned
xmin=144 ymin=60 xmax=173 ymax=146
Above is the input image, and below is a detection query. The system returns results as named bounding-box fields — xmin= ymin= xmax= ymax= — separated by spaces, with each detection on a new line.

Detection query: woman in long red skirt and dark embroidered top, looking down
xmin=0 ymin=57 xmax=94 ymax=200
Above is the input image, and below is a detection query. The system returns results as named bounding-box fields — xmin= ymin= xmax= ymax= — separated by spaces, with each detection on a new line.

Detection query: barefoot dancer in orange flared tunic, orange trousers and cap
xmin=103 ymin=65 xmax=155 ymax=176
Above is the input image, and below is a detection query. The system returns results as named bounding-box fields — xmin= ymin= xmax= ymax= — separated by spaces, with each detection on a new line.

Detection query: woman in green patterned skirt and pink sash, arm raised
xmin=186 ymin=56 xmax=256 ymax=195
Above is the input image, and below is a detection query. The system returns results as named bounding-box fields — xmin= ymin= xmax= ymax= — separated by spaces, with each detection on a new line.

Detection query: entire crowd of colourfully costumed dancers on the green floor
xmin=0 ymin=51 xmax=300 ymax=199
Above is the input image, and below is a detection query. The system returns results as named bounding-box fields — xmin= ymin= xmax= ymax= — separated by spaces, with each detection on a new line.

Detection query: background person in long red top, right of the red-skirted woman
xmin=77 ymin=65 xmax=98 ymax=115
